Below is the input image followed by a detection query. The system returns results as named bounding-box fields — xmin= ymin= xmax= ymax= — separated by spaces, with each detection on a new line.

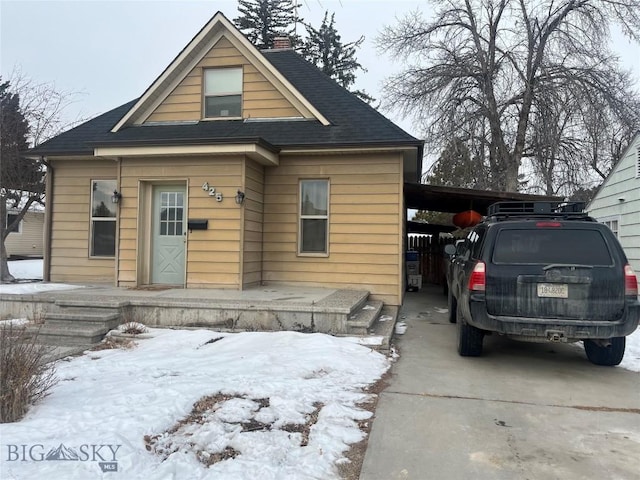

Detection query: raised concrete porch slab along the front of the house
xmin=0 ymin=284 xmax=390 ymax=342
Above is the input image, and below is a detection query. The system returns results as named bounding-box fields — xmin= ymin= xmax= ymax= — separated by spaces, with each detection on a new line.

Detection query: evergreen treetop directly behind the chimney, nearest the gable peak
xmin=233 ymin=0 xmax=301 ymax=49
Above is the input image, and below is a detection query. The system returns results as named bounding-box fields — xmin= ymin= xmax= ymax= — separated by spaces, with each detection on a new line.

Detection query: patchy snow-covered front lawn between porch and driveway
xmin=0 ymin=329 xmax=389 ymax=480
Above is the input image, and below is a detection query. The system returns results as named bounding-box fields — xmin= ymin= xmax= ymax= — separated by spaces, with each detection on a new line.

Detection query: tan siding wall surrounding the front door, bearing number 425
xmin=118 ymin=156 xmax=244 ymax=288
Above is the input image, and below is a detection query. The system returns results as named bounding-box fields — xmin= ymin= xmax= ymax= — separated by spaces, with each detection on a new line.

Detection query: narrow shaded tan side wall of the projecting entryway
xmin=242 ymin=159 xmax=265 ymax=287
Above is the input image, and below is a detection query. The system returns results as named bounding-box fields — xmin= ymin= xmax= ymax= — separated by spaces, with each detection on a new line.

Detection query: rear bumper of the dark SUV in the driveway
xmin=468 ymin=295 xmax=640 ymax=340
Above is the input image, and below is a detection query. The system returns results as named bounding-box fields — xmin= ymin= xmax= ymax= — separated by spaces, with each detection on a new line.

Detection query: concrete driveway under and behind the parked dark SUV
xmin=360 ymin=287 xmax=640 ymax=480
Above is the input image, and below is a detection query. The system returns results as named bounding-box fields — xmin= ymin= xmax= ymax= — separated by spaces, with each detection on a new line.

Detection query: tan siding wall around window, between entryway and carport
xmin=263 ymin=154 xmax=403 ymax=305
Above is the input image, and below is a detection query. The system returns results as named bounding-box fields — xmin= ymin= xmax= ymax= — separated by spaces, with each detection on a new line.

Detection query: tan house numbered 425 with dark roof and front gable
xmin=32 ymin=13 xmax=423 ymax=305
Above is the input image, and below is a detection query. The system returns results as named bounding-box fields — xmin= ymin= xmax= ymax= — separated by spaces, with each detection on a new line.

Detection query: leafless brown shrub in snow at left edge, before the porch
xmin=0 ymin=323 xmax=57 ymax=423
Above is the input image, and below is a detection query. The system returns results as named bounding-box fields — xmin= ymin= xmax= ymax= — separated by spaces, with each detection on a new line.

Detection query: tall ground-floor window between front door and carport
xmin=298 ymin=180 xmax=329 ymax=255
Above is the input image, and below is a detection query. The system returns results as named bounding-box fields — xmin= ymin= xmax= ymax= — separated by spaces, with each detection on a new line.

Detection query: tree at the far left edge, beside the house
xmin=0 ymin=70 xmax=83 ymax=283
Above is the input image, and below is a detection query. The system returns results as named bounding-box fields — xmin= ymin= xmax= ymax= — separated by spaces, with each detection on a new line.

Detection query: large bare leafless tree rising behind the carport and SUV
xmin=378 ymin=0 xmax=640 ymax=191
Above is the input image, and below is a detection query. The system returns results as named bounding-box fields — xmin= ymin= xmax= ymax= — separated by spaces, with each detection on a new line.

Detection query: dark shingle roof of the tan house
xmin=31 ymin=50 xmax=422 ymax=155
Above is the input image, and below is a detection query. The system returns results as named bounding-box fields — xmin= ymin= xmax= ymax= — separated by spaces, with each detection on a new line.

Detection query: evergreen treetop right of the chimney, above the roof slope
xmin=300 ymin=12 xmax=374 ymax=103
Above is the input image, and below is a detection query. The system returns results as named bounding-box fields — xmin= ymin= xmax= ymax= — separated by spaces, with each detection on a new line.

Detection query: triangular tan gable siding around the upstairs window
xmin=146 ymin=37 xmax=302 ymax=122
